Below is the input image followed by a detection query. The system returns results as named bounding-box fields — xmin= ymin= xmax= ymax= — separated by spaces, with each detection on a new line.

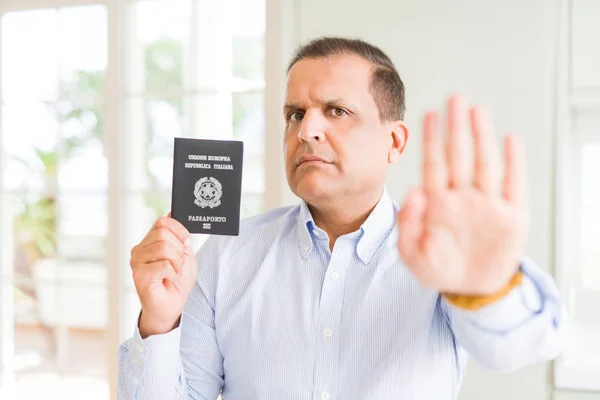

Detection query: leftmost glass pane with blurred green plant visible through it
xmin=0 ymin=5 xmax=108 ymax=399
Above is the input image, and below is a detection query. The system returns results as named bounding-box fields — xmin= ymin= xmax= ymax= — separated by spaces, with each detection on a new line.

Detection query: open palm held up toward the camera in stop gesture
xmin=397 ymin=96 xmax=529 ymax=295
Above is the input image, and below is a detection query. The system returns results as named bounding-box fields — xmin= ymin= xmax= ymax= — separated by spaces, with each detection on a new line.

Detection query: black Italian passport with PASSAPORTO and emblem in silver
xmin=171 ymin=138 xmax=244 ymax=236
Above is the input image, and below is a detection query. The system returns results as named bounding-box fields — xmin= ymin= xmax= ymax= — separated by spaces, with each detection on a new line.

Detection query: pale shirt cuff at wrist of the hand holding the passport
xmin=129 ymin=326 xmax=181 ymax=382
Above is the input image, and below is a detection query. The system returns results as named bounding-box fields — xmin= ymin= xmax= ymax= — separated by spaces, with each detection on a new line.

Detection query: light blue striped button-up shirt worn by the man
xmin=118 ymin=189 xmax=566 ymax=400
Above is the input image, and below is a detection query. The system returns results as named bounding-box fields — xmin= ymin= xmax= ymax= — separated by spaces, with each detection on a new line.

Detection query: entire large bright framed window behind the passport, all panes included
xmin=0 ymin=0 xmax=265 ymax=400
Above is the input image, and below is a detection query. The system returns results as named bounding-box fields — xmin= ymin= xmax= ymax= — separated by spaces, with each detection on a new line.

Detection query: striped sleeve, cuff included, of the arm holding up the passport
xmin=117 ymin=239 xmax=223 ymax=400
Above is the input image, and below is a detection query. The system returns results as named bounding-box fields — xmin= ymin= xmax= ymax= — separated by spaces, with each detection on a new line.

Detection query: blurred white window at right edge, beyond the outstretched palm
xmin=554 ymin=0 xmax=600 ymax=391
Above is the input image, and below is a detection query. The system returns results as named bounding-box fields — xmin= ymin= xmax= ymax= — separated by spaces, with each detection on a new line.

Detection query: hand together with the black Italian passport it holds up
xmin=135 ymin=138 xmax=243 ymax=338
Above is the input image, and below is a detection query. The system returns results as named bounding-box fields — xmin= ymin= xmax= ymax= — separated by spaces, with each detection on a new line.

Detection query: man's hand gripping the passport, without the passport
xmin=130 ymin=214 xmax=197 ymax=338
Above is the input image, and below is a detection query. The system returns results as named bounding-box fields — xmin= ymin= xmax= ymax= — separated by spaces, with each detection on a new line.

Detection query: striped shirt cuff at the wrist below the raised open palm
xmin=447 ymin=260 xmax=548 ymax=334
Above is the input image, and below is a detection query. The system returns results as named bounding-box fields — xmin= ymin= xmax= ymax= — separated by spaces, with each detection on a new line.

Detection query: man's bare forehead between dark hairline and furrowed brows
xmin=286 ymin=55 xmax=371 ymax=101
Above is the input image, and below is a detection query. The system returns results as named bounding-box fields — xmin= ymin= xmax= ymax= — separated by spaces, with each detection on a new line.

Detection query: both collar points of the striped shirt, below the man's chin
xmin=297 ymin=187 xmax=397 ymax=265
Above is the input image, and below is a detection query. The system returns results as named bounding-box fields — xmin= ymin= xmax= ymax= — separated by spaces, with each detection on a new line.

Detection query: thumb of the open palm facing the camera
xmin=397 ymin=188 xmax=427 ymax=265
